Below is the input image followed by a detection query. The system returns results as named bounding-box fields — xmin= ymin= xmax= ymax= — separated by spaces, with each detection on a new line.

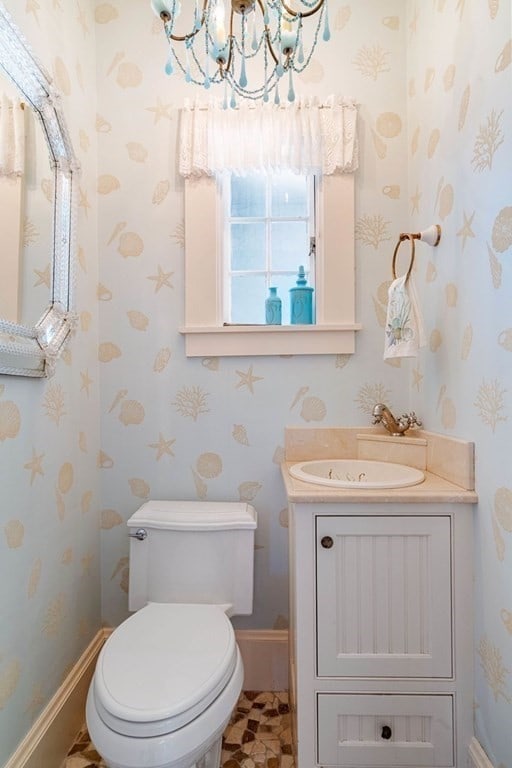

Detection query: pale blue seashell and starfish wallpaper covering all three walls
xmin=0 ymin=0 xmax=512 ymax=766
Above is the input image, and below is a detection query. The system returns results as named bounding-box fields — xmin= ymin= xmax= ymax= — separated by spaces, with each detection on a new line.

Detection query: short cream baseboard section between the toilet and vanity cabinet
xmin=235 ymin=629 xmax=288 ymax=691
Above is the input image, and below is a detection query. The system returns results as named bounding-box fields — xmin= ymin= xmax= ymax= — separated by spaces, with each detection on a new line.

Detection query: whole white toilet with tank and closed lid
xmin=86 ymin=501 xmax=256 ymax=768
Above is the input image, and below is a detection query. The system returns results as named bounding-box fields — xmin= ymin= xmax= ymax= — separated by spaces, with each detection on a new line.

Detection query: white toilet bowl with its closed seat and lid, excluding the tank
xmin=86 ymin=603 xmax=243 ymax=768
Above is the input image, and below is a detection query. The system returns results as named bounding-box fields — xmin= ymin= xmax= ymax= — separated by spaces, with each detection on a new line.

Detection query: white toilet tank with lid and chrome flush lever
xmin=127 ymin=501 xmax=256 ymax=616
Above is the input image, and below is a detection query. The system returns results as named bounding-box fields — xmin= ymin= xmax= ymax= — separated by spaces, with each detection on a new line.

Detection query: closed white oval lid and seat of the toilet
xmin=94 ymin=603 xmax=236 ymax=736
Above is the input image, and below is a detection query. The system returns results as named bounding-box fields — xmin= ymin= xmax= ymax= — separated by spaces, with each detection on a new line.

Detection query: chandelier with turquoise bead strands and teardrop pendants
xmin=151 ymin=0 xmax=331 ymax=108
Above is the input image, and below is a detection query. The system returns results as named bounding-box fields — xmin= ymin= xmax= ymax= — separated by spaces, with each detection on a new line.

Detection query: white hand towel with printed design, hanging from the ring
xmin=384 ymin=275 xmax=426 ymax=360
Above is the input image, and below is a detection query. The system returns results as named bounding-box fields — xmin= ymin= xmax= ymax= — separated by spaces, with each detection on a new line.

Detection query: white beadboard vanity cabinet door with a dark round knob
xmin=316 ymin=515 xmax=452 ymax=677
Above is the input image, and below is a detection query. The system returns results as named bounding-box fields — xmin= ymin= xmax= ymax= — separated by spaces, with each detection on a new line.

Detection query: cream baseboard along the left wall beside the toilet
xmin=4 ymin=629 xmax=107 ymax=768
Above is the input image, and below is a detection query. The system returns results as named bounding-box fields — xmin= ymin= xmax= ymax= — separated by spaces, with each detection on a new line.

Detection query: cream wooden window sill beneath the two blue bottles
xmin=180 ymin=323 xmax=361 ymax=357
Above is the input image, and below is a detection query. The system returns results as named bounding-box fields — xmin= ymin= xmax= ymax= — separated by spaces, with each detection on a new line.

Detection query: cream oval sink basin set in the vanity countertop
xmin=289 ymin=459 xmax=425 ymax=490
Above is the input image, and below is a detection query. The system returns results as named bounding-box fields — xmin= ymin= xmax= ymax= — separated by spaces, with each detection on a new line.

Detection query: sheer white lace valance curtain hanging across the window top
xmin=179 ymin=97 xmax=358 ymax=177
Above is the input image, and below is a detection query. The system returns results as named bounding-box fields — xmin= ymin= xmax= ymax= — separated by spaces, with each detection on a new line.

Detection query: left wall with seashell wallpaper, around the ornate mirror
xmin=0 ymin=0 xmax=101 ymax=765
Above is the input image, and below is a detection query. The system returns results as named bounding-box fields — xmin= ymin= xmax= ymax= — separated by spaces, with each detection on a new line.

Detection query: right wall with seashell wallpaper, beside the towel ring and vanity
xmin=407 ymin=0 xmax=512 ymax=768
